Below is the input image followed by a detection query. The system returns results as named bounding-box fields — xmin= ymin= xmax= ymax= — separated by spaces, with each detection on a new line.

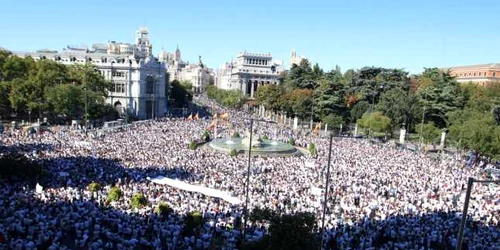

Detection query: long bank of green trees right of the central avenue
xmin=252 ymin=60 xmax=500 ymax=158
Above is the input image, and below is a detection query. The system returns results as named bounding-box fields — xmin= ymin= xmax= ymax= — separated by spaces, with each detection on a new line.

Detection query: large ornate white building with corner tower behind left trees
xmin=14 ymin=27 xmax=167 ymax=119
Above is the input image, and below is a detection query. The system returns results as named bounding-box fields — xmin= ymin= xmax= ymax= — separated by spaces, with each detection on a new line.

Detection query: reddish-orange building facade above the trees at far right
xmin=445 ymin=63 xmax=500 ymax=86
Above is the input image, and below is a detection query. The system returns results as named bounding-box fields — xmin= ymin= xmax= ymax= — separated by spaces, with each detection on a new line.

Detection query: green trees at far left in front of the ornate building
xmin=0 ymin=50 xmax=116 ymax=123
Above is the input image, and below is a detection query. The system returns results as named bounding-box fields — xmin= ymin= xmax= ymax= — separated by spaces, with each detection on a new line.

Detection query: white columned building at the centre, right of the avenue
xmin=216 ymin=51 xmax=284 ymax=98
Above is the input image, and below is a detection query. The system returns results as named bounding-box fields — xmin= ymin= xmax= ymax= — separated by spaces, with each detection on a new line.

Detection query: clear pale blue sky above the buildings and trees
xmin=0 ymin=0 xmax=500 ymax=73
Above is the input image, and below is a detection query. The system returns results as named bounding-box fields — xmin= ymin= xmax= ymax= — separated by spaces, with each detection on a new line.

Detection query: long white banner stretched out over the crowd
xmin=147 ymin=176 xmax=241 ymax=205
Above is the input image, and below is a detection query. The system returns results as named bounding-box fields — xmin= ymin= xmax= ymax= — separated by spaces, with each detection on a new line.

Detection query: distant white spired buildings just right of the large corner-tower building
xmin=158 ymin=46 xmax=213 ymax=93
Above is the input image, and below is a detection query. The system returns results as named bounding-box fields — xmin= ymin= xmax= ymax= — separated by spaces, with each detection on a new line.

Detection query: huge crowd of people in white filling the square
xmin=0 ymin=100 xmax=500 ymax=249
